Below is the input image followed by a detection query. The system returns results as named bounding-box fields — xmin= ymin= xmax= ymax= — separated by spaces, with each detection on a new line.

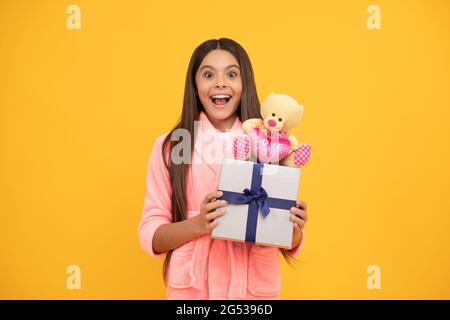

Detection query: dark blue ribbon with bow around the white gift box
xmin=219 ymin=163 xmax=296 ymax=242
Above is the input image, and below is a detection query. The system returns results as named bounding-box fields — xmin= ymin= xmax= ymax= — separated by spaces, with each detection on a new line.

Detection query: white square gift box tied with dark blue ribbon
xmin=211 ymin=159 xmax=301 ymax=249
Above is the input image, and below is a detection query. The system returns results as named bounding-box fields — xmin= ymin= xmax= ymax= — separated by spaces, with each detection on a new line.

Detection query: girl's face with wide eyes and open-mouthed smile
xmin=195 ymin=49 xmax=242 ymax=131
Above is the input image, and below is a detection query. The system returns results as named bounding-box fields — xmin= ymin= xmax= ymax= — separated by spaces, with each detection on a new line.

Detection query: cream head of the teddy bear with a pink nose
xmin=261 ymin=92 xmax=304 ymax=131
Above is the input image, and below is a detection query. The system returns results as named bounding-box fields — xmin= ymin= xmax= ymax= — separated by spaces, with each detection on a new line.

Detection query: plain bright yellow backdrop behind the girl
xmin=0 ymin=0 xmax=450 ymax=299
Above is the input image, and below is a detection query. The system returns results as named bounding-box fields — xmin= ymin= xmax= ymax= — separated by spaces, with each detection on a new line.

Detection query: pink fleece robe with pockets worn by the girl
xmin=138 ymin=112 xmax=304 ymax=300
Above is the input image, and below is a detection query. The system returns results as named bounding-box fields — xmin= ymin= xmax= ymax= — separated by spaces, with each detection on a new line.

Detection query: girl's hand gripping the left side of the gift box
xmin=192 ymin=191 xmax=227 ymax=236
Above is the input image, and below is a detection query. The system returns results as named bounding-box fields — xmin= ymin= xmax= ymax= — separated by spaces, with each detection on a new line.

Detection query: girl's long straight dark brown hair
xmin=162 ymin=38 xmax=291 ymax=280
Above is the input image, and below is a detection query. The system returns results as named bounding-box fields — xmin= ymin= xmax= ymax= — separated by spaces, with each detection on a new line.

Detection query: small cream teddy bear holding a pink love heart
xmin=233 ymin=92 xmax=311 ymax=168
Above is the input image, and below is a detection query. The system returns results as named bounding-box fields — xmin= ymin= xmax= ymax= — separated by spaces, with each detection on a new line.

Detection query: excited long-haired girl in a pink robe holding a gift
xmin=138 ymin=38 xmax=307 ymax=300
